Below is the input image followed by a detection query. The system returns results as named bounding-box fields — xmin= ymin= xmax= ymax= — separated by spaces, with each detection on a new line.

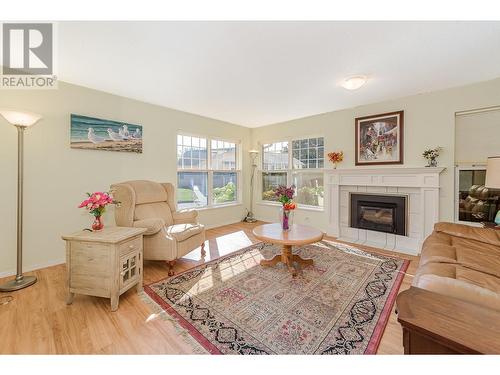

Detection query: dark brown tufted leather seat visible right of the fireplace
xmin=458 ymin=185 xmax=499 ymax=222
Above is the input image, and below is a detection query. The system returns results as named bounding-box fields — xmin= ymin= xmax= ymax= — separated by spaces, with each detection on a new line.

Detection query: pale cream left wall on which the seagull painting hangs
xmin=0 ymin=83 xmax=251 ymax=275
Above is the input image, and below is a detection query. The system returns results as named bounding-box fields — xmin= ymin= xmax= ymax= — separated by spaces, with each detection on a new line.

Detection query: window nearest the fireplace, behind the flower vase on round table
xmin=262 ymin=137 xmax=324 ymax=207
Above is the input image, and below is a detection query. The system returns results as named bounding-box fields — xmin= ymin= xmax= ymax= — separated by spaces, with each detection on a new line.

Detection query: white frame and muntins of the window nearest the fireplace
xmin=257 ymin=135 xmax=326 ymax=212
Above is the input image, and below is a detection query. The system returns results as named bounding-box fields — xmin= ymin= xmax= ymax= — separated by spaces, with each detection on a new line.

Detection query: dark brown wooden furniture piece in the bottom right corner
xmin=396 ymin=287 xmax=500 ymax=354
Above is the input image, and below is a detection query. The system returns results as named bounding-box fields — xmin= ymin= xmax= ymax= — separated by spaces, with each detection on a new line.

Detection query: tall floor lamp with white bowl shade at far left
xmin=0 ymin=109 xmax=42 ymax=292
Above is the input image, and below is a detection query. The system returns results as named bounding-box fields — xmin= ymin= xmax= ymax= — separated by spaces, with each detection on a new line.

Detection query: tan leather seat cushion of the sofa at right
xmin=412 ymin=263 xmax=500 ymax=311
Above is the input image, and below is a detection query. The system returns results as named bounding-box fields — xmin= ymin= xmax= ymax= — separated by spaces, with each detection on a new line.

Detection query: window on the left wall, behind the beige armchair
xmin=177 ymin=134 xmax=240 ymax=209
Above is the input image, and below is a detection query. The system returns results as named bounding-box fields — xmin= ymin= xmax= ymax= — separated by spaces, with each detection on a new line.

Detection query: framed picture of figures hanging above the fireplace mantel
xmin=355 ymin=111 xmax=404 ymax=165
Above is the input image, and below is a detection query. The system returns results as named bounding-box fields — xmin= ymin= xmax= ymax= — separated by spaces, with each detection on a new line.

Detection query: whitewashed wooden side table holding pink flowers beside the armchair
xmin=62 ymin=227 xmax=146 ymax=311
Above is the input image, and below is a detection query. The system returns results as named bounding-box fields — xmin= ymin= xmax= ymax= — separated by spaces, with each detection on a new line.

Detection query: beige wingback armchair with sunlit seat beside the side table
xmin=111 ymin=180 xmax=205 ymax=276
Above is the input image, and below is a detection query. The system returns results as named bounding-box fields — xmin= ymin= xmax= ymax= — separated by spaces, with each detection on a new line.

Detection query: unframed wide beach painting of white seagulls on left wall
xmin=71 ymin=114 xmax=142 ymax=153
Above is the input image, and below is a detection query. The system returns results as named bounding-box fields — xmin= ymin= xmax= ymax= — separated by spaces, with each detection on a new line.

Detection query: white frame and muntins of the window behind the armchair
xmin=175 ymin=131 xmax=242 ymax=210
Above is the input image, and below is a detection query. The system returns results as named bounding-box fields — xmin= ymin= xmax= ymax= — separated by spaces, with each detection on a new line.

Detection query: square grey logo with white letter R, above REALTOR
xmin=3 ymin=23 xmax=53 ymax=75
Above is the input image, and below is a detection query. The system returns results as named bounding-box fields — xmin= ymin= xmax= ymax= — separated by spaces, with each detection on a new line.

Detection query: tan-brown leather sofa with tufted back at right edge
xmin=412 ymin=223 xmax=500 ymax=311
